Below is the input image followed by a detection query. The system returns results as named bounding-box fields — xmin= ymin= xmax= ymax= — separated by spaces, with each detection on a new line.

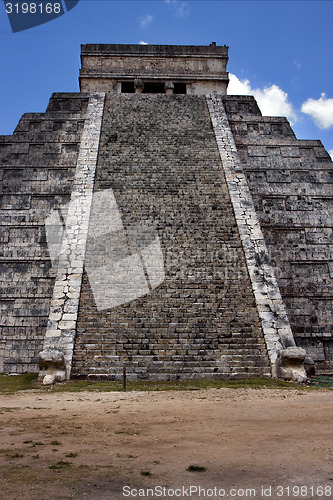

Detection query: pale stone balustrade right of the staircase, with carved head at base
xmin=206 ymin=94 xmax=307 ymax=383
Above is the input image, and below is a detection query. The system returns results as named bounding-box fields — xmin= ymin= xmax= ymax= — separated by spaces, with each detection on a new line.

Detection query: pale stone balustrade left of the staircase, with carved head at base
xmin=38 ymin=93 xmax=105 ymax=385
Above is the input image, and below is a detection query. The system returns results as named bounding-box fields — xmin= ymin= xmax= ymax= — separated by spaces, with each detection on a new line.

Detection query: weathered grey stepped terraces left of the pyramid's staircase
xmin=0 ymin=94 xmax=88 ymax=373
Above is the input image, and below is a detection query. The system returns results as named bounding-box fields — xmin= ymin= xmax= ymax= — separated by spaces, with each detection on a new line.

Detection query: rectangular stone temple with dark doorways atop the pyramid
xmin=79 ymin=42 xmax=229 ymax=95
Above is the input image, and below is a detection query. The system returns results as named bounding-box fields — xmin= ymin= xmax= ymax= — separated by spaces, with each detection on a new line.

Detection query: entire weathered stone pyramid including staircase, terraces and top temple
xmin=0 ymin=44 xmax=333 ymax=383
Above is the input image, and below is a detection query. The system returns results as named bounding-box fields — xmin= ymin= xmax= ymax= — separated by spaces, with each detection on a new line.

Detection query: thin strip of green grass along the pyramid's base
xmin=0 ymin=374 xmax=326 ymax=395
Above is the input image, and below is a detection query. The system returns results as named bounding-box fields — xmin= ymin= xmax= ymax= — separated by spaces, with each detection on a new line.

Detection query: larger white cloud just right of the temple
xmin=228 ymin=73 xmax=298 ymax=124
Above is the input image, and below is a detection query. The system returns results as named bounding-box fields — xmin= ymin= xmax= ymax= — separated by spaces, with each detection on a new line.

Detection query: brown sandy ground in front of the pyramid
xmin=0 ymin=389 xmax=333 ymax=500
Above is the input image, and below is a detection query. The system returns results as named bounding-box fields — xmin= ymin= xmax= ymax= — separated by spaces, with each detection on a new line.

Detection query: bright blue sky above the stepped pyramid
xmin=0 ymin=0 xmax=333 ymax=154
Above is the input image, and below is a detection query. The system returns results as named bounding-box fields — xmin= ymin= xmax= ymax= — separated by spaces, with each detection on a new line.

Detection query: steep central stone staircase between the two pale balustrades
xmin=72 ymin=94 xmax=270 ymax=380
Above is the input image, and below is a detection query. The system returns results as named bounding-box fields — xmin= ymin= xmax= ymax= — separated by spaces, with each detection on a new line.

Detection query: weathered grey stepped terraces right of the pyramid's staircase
xmin=223 ymin=96 xmax=333 ymax=372
